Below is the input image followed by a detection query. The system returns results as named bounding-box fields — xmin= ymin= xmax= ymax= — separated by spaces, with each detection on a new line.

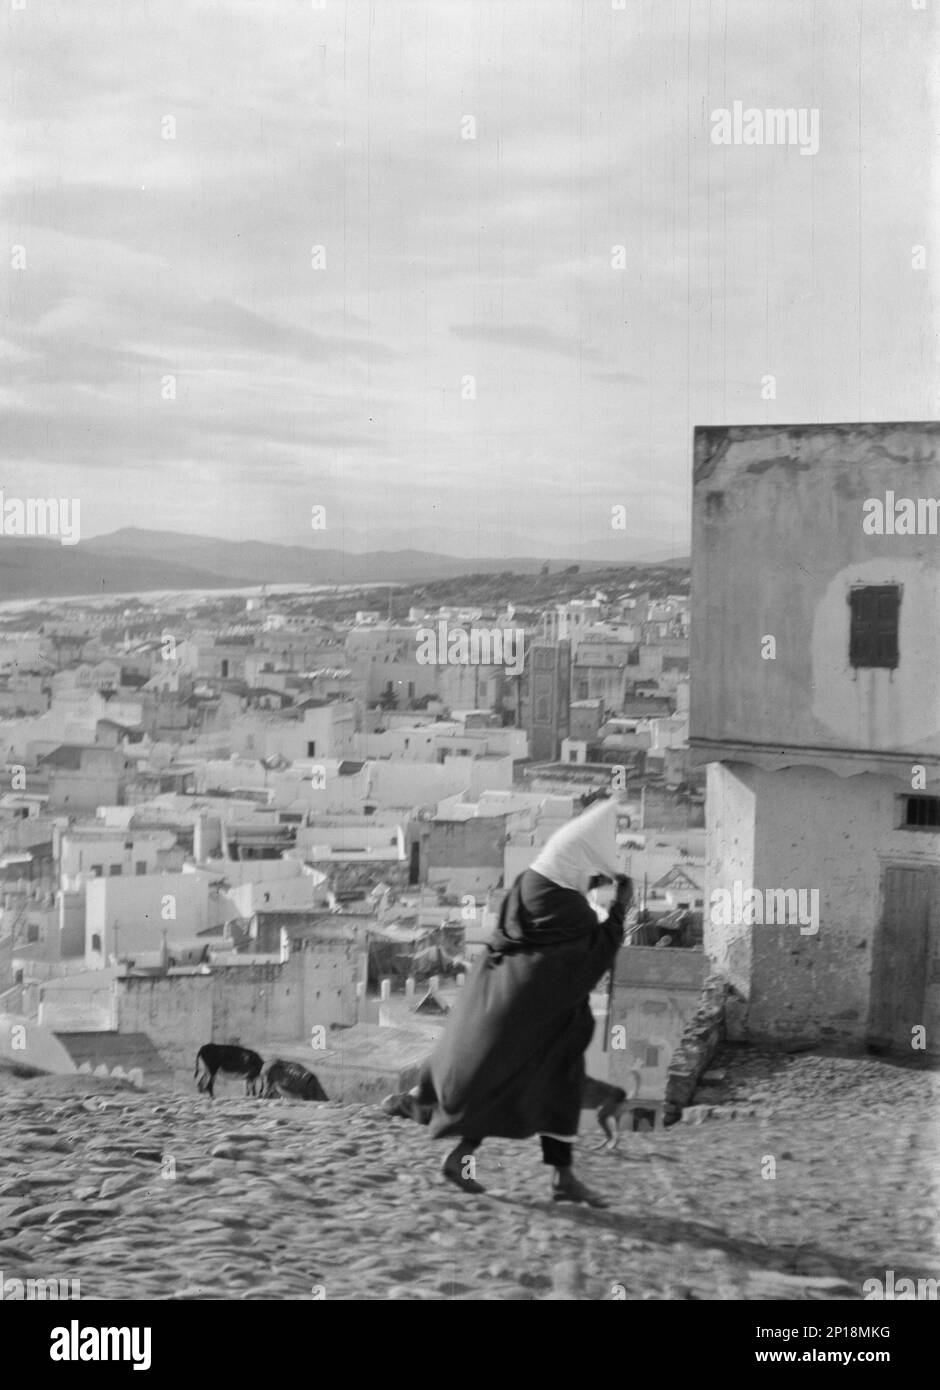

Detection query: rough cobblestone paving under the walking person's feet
xmin=0 ymin=1047 xmax=940 ymax=1300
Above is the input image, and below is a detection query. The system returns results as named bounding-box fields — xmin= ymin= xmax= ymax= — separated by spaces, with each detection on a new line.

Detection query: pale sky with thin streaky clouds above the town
xmin=0 ymin=0 xmax=940 ymax=560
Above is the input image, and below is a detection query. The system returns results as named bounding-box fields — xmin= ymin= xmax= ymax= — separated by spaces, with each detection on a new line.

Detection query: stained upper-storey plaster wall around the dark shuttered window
xmin=690 ymin=424 xmax=940 ymax=756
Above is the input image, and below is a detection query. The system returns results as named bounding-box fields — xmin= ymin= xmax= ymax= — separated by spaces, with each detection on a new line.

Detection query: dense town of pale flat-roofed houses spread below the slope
xmin=0 ymin=567 xmax=704 ymax=1112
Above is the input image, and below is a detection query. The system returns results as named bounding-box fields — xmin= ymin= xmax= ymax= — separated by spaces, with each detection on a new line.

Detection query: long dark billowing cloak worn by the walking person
xmin=417 ymin=869 xmax=623 ymax=1140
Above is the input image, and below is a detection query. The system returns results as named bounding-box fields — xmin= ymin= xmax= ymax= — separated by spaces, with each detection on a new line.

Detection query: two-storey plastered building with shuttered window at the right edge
xmin=690 ymin=424 xmax=940 ymax=1055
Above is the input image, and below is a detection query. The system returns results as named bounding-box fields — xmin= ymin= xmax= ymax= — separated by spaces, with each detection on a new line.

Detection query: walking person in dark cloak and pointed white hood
xmin=384 ymin=801 xmax=633 ymax=1205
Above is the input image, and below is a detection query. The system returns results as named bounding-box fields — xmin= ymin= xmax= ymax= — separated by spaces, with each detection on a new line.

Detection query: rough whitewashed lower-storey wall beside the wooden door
xmin=705 ymin=765 xmax=940 ymax=1041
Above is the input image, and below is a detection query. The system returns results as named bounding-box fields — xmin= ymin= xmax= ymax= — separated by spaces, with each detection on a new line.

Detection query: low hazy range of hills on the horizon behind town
xmin=0 ymin=527 xmax=687 ymax=599
